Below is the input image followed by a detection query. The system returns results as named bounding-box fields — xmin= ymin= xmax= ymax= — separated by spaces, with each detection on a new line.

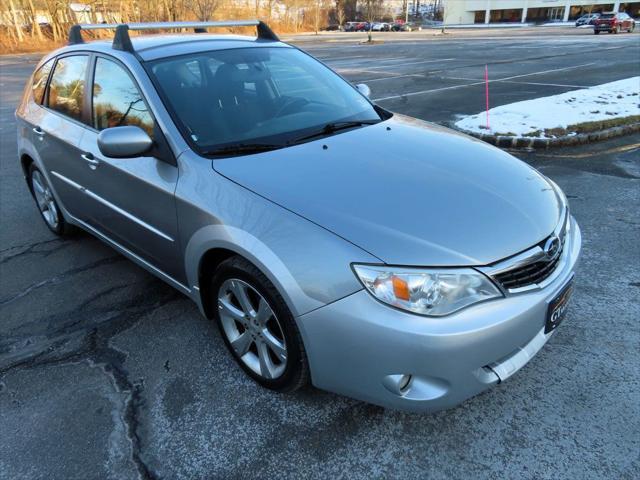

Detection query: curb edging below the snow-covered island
xmin=459 ymin=122 xmax=640 ymax=150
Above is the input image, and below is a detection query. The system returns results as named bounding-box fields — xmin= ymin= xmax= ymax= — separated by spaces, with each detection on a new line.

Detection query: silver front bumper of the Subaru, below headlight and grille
xmin=298 ymin=218 xmax=581 ymax=412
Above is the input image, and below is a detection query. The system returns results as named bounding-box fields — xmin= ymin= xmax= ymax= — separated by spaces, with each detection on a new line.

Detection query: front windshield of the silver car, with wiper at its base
xmin=150 ymin=47 xmax=381 ymax=154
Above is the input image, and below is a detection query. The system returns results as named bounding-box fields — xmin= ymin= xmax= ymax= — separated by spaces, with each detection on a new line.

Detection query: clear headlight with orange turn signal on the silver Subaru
xmin=353 ymin=265 xmax=502 ymax=317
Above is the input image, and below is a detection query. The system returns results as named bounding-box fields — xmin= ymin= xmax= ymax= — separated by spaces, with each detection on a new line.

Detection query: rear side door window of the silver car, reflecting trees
xmin=49 ymin=55 xmax=89 ymax=120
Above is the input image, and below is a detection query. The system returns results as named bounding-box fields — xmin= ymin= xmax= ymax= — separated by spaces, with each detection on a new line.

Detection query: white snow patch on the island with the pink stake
xmin=455 ymin=77 xmax=640 ymax=138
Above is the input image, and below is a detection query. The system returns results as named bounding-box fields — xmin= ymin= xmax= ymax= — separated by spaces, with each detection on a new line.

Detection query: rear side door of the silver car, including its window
xmin=32 ymin=53 xmax=89 ymax=220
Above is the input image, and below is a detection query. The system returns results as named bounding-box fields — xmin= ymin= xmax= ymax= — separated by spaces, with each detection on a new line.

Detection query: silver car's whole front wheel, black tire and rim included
xmin=209 ymin=256 xmax=309 ymax=392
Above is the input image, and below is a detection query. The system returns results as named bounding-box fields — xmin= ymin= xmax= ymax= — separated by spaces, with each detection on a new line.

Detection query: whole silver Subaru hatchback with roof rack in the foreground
xmin=16 ymin=21 xmax=581 ymax=412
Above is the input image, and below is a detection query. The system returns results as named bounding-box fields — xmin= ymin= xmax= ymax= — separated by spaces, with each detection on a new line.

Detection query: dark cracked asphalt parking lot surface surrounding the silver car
xmin=0 ymin=28 xmax=640 ymax=479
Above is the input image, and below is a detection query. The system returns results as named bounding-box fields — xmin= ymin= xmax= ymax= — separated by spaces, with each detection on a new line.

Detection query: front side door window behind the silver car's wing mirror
xmin=92 ymin=57 xmax=153 ymax=135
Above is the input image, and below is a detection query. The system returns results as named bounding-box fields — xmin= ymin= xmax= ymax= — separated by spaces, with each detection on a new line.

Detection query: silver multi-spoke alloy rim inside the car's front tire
xmin=218 ymin=278 xmax=287 ymax=380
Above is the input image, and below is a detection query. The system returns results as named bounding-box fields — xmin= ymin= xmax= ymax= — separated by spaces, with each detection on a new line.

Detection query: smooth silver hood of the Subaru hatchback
xmin=213 ymin=115 xmax=562 ymax=266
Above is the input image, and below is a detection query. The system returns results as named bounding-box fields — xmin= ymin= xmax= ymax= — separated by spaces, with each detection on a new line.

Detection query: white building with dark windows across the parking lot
xmin=445 ymin=0 xmax=640 ymax=25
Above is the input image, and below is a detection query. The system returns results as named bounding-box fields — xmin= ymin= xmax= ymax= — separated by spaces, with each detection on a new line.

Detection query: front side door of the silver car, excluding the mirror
xmin=80 ymin=55 xmax=184 ymax=281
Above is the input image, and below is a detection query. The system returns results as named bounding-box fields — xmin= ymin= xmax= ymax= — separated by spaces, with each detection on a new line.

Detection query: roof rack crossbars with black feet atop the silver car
xmin=69 ymin=20 xmax=280 ymax=53
